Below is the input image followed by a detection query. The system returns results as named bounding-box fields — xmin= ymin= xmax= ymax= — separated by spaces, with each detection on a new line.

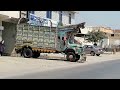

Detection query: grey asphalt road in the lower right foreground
xmin=9 ymin=60 xmax=120 ymax=79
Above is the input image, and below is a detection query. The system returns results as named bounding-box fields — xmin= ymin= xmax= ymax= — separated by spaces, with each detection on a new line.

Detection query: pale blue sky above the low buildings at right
xmin=75 ymin=11 xmax=120 ymax=29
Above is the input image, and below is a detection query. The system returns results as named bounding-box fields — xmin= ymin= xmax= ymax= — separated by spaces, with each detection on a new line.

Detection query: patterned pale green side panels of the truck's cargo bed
xmin=16 ymin=24 xmax=57 ymax=49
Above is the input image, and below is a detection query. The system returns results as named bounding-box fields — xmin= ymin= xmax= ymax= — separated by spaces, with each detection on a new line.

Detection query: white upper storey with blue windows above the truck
xmin=29 ymin=11 xmax=76 ymax=25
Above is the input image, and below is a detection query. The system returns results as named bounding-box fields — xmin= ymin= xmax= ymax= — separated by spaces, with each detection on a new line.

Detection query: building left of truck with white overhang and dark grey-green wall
xmin=0 ymin=11 xmax=20 ymax=54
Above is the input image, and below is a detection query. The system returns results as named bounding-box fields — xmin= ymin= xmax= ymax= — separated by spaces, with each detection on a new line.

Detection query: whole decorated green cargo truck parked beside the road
xmin=15 ymin=18 xmax=86 ymax=62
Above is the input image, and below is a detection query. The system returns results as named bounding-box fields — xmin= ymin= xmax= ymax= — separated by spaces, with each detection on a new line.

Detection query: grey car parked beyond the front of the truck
xmin=84 ymin=45 xmax=104 ymax=56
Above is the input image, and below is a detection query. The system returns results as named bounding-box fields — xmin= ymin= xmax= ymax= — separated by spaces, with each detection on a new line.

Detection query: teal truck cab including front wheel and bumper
xmin=58 ymin=22 xmax=86 ymax=62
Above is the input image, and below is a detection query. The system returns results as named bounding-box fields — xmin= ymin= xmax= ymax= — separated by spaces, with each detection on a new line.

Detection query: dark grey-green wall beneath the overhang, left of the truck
xmin=2 ymin=22 xmax=16 ymax=55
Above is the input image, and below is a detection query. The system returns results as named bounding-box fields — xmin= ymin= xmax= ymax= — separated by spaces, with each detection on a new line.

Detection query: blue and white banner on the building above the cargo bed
xmin=28 ymin=13 xmax=58 ymax=27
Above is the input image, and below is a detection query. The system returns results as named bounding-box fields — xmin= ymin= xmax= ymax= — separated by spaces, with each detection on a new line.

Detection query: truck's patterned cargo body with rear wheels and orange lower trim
xmin=15 ymin=17 xmax=57 ymax=58
